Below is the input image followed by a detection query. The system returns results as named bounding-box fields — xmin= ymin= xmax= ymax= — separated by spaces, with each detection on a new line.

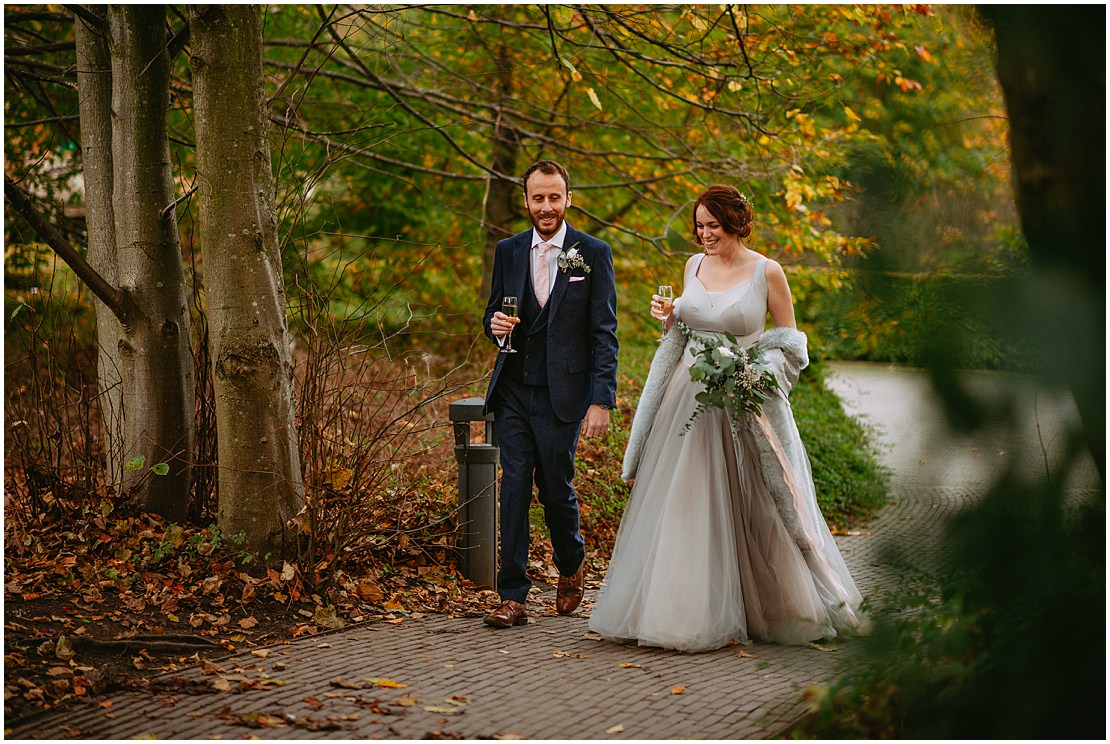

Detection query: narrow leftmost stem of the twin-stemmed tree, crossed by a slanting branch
xmin=75 ymin=6 xmax=125 ymax=490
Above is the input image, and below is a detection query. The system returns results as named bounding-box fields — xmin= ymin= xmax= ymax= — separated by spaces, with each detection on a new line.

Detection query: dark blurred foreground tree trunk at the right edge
xmin=981 ymin=6 xmax=1106 ymax=477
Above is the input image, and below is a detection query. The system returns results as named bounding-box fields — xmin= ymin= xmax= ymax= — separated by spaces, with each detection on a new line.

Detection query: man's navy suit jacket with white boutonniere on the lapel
xmin=483 ymin=224 xmax=617 ymax=422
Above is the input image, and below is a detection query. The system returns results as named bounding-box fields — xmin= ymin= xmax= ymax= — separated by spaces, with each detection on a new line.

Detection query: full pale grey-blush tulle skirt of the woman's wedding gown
xmin=589 ymin=364 xmax=861 ymax=652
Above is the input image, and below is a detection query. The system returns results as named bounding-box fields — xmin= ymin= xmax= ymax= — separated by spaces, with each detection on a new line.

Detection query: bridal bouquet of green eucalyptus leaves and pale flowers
xmin=678 ymin=321 xmax=778 ymax=434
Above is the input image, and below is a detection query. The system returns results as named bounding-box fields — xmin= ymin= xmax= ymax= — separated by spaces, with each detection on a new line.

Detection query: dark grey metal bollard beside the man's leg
xmin=448 ymin=398 xmax=501 ymax=587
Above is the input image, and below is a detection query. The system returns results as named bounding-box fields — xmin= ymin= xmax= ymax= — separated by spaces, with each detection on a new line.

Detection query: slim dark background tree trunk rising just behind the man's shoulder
xmin=481 ymin=44 xmax=523 ymax=302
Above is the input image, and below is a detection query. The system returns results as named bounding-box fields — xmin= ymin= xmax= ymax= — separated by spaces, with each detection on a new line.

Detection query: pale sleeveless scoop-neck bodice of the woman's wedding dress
xmin=676 ymin=253 xmax=767 ymax=364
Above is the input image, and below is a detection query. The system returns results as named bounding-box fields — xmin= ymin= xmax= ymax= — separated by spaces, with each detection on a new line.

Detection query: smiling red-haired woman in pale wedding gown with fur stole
xmin=589 ymin=185 xmax=864 ymax=652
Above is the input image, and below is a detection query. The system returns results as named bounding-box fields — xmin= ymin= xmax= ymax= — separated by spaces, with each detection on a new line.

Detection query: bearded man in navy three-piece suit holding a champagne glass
xmin=483 ymin=160 xmax=617 ymax=627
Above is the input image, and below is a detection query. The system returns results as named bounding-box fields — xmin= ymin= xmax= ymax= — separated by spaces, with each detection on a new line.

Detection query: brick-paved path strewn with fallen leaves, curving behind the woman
xmin=8 ymin=366 xmax=1097 ymax=740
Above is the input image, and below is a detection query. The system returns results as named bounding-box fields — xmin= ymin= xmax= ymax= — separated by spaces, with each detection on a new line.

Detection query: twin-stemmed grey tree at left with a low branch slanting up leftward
xmin=4 ymin=6 xmax=195 ymax=520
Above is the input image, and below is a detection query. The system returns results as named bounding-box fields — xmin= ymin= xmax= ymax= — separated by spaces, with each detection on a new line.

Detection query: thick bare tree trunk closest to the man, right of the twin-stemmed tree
xmin=189 ymin=6 xmax=304 ymax=553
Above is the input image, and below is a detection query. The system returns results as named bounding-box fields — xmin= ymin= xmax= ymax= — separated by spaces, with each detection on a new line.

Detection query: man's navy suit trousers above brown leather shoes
xmin=491 ymin=378 xmax=586 ymax=603
